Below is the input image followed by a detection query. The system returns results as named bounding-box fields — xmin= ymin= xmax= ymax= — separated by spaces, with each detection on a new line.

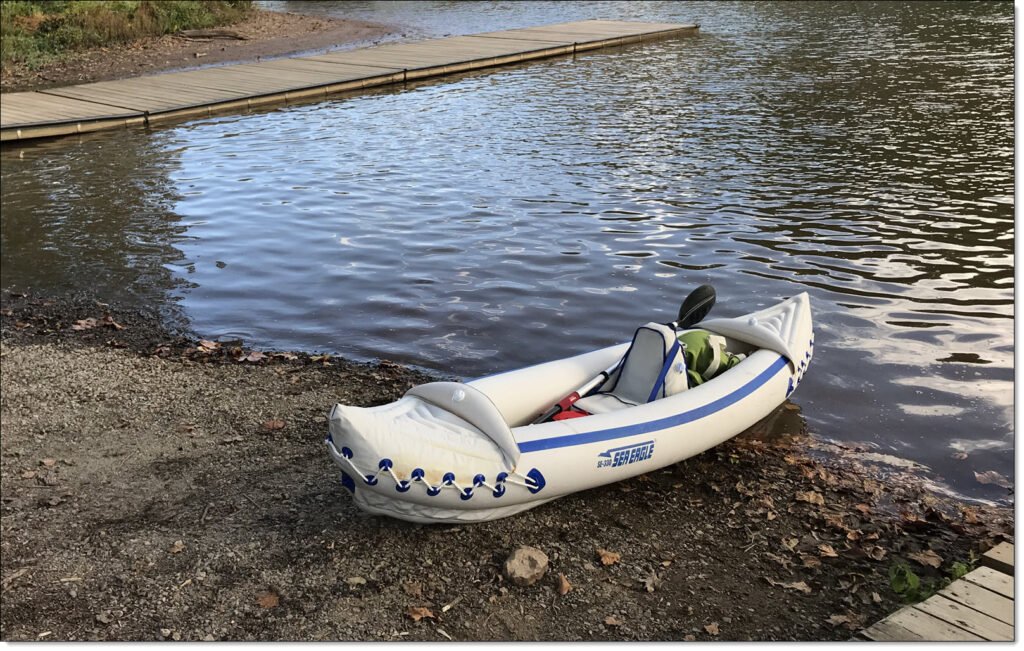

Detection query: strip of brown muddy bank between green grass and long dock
xmin=0 ymin=9 xmax=401 ymax=92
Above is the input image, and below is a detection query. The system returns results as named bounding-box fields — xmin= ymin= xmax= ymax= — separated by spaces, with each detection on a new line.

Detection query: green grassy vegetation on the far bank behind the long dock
xmin=0 ymin=0 xmax=252 ymax=68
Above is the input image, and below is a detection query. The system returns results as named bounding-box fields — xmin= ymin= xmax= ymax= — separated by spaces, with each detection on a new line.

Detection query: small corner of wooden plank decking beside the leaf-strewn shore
xmin=860 ymin=543 xmax=1014 ymax=642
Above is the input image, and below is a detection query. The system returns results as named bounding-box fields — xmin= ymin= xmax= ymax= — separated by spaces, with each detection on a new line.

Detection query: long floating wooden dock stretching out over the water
xmin=0 ymin=20 xmax=697 ymax=141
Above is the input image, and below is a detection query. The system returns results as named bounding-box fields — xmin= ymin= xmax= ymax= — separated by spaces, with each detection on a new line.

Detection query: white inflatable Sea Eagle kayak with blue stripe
xmin=327 ymin=288 xmax=814 ymax=522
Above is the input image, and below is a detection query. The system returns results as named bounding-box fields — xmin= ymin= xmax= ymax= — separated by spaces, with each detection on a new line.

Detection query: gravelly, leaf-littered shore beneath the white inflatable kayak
xmin=0 ymin=293 xmax=1013 ymax=641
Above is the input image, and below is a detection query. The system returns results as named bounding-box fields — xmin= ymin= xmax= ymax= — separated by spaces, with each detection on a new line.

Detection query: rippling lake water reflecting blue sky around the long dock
xmin=2 ymin=2 xmax=1014 ymax=500
